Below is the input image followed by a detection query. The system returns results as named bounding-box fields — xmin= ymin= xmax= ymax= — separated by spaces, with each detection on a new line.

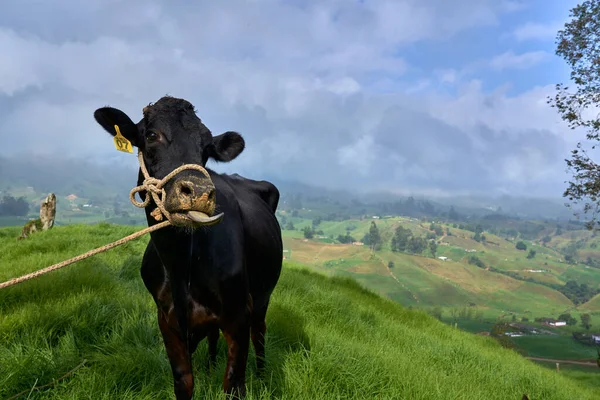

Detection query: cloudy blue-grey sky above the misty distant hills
xmin=0 ymin=0 xmax=584 ymax=198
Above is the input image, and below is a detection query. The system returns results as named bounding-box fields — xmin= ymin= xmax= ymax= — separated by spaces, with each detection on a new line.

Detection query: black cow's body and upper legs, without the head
xmin=141 ymin=171 xmax=283 ymax=397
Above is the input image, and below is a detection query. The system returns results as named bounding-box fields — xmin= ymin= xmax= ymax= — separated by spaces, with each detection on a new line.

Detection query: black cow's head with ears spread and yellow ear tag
xmin=94 ymin=97 xmax=244 ymax=227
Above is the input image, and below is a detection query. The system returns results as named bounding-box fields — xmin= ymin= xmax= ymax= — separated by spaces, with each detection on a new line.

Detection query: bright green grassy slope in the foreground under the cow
xmin=0 ymin=225 xmax=597 ymax=400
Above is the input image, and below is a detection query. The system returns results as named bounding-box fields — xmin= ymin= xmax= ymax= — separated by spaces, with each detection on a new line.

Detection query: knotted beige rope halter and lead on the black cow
xmin=0 ymin=150 xmax=210 ymax=289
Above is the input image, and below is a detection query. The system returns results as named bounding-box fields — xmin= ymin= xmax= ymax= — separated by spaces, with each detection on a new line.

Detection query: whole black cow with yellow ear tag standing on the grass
xmin=94 ymin=96 xmax=283 ymax=399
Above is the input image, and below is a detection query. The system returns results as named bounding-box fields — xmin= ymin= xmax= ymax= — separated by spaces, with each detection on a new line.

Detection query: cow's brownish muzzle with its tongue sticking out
xmin=165 ymin=175 xmax=223 ymax=228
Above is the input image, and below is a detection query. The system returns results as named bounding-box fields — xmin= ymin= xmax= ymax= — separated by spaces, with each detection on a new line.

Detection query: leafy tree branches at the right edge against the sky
xmin=548 ymin=0 xmax=600 ymax=229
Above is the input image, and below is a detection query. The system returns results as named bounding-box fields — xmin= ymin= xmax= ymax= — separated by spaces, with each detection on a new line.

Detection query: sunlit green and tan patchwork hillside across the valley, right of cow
xmin=283 ymin=216 xmax=600 ymax=318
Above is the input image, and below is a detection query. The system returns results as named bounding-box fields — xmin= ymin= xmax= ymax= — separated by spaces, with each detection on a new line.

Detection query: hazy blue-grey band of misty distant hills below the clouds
xmin=0 ymin=154 xmax=574 ymax=220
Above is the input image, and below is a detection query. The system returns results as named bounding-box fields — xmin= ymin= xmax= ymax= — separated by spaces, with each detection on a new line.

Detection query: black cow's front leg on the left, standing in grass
xmin=158 ymin=309 xmax=194 ymax=400
